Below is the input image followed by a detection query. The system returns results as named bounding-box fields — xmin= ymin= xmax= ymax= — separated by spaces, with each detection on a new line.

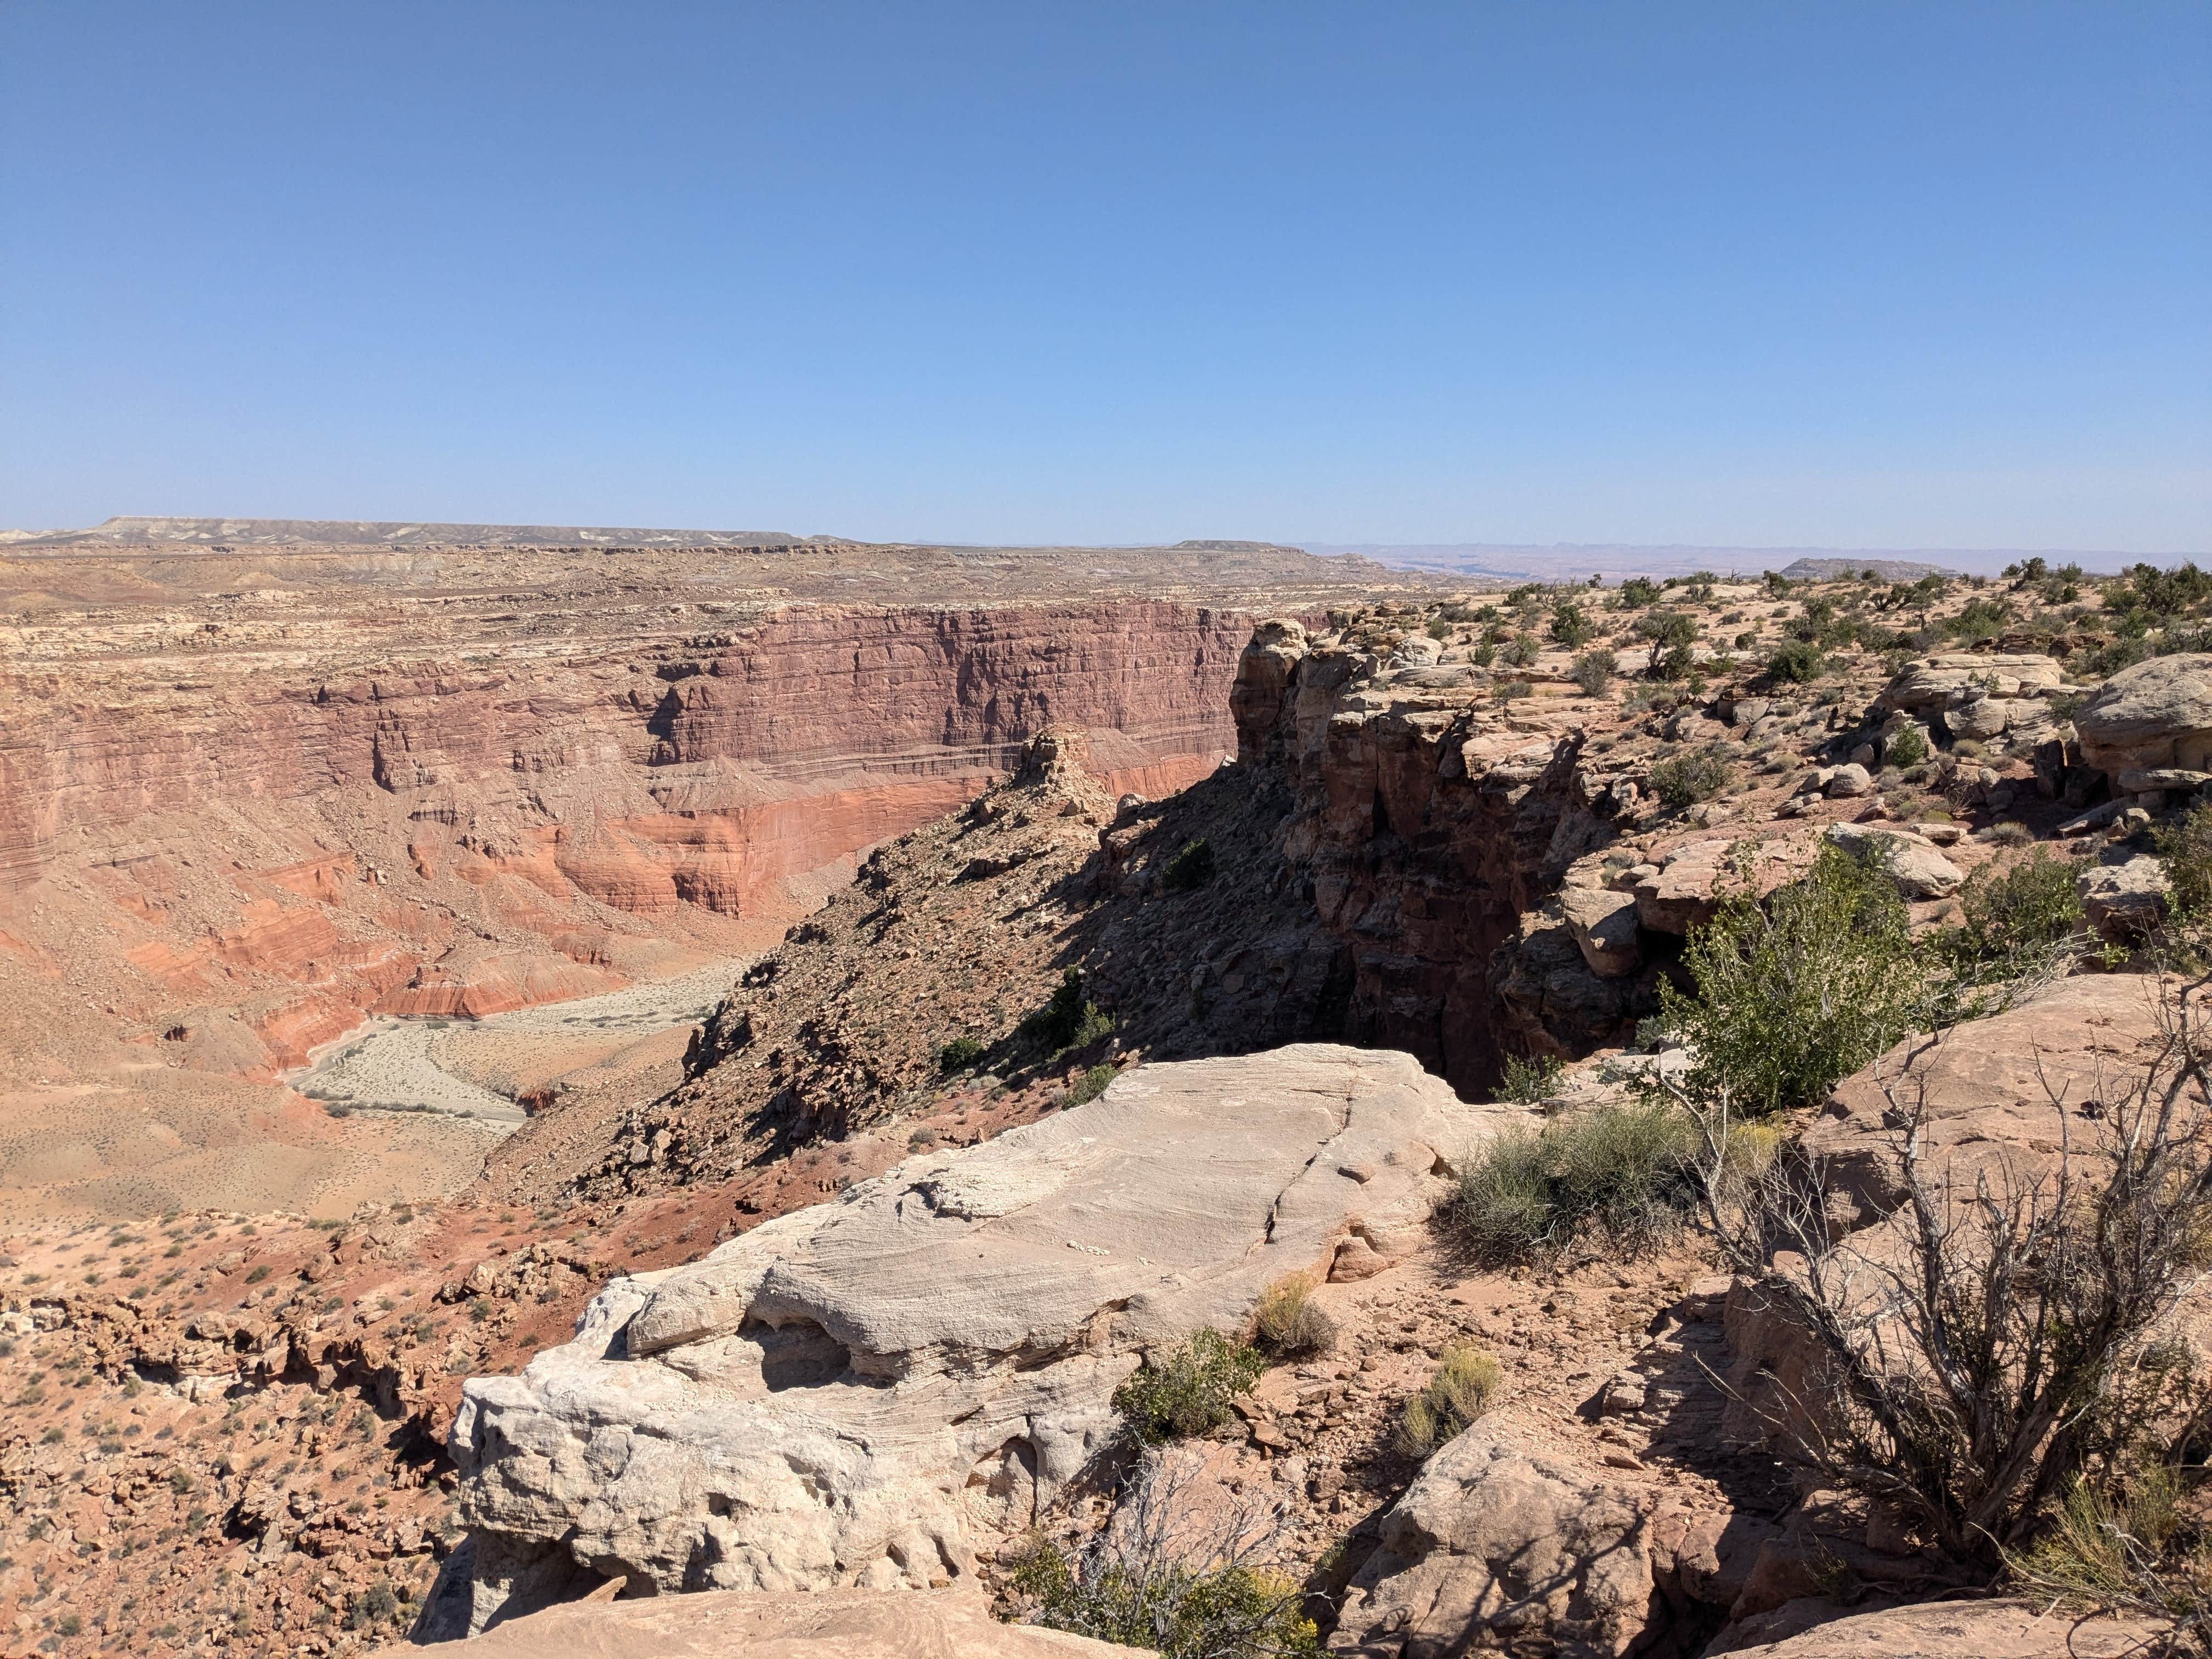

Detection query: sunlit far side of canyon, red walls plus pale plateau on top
xmin=0 ymin=520 xmax=1424 ymax=1219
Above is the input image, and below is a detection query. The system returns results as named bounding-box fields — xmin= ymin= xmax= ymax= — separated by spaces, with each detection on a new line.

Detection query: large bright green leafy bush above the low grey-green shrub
xmin=1659 ymin=845 xmax=1940 ymax=1113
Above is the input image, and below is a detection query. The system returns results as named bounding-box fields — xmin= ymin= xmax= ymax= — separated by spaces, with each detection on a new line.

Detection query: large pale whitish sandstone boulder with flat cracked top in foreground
xmin=452 ymin=1044 xmax=1520 ymax=1628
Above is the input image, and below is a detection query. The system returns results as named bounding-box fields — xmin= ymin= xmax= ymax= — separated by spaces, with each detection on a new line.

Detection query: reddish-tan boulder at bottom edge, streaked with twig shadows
xmin=1329 ymin=1420 xmax=1652 ymax=1659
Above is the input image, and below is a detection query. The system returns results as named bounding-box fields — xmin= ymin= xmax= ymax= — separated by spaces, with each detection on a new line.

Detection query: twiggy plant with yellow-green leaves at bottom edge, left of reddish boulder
xmin=1000 ymin=1458 xmax=1321 ymax=1659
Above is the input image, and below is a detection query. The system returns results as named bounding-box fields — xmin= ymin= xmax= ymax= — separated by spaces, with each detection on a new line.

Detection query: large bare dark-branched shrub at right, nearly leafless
xmin=1672 ymin=995 xmax=2212 ymax=1568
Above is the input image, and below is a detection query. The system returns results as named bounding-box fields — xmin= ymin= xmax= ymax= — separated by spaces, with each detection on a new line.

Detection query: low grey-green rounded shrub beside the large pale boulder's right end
xmin=1442 ymin=1102 xmax=1697 ymax=1265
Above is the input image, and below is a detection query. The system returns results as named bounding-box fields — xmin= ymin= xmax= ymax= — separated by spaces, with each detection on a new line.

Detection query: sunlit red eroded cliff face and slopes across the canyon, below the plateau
xmin=0 ymin=600 xmax=1250 ymax=1210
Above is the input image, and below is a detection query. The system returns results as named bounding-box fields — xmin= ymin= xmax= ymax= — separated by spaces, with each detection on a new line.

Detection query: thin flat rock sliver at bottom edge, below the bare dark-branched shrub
xmin=1708 ymin=1601 xmax=2159 ymax=1659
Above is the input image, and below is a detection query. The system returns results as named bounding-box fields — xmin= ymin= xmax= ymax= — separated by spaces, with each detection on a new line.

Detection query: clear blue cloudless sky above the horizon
xmin=0 ymin=0 xmax=2212 ymax=551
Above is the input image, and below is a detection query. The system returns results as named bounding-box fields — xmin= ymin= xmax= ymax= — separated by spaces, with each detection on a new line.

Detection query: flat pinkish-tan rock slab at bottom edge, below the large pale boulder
xmin=376 ymin=1590 xmax=1150 ymax=1659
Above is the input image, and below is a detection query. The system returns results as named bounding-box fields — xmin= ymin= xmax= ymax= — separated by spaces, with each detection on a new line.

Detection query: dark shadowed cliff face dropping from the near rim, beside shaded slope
xmin=1232 ymin=622 xmax=1648 ymax=1093
